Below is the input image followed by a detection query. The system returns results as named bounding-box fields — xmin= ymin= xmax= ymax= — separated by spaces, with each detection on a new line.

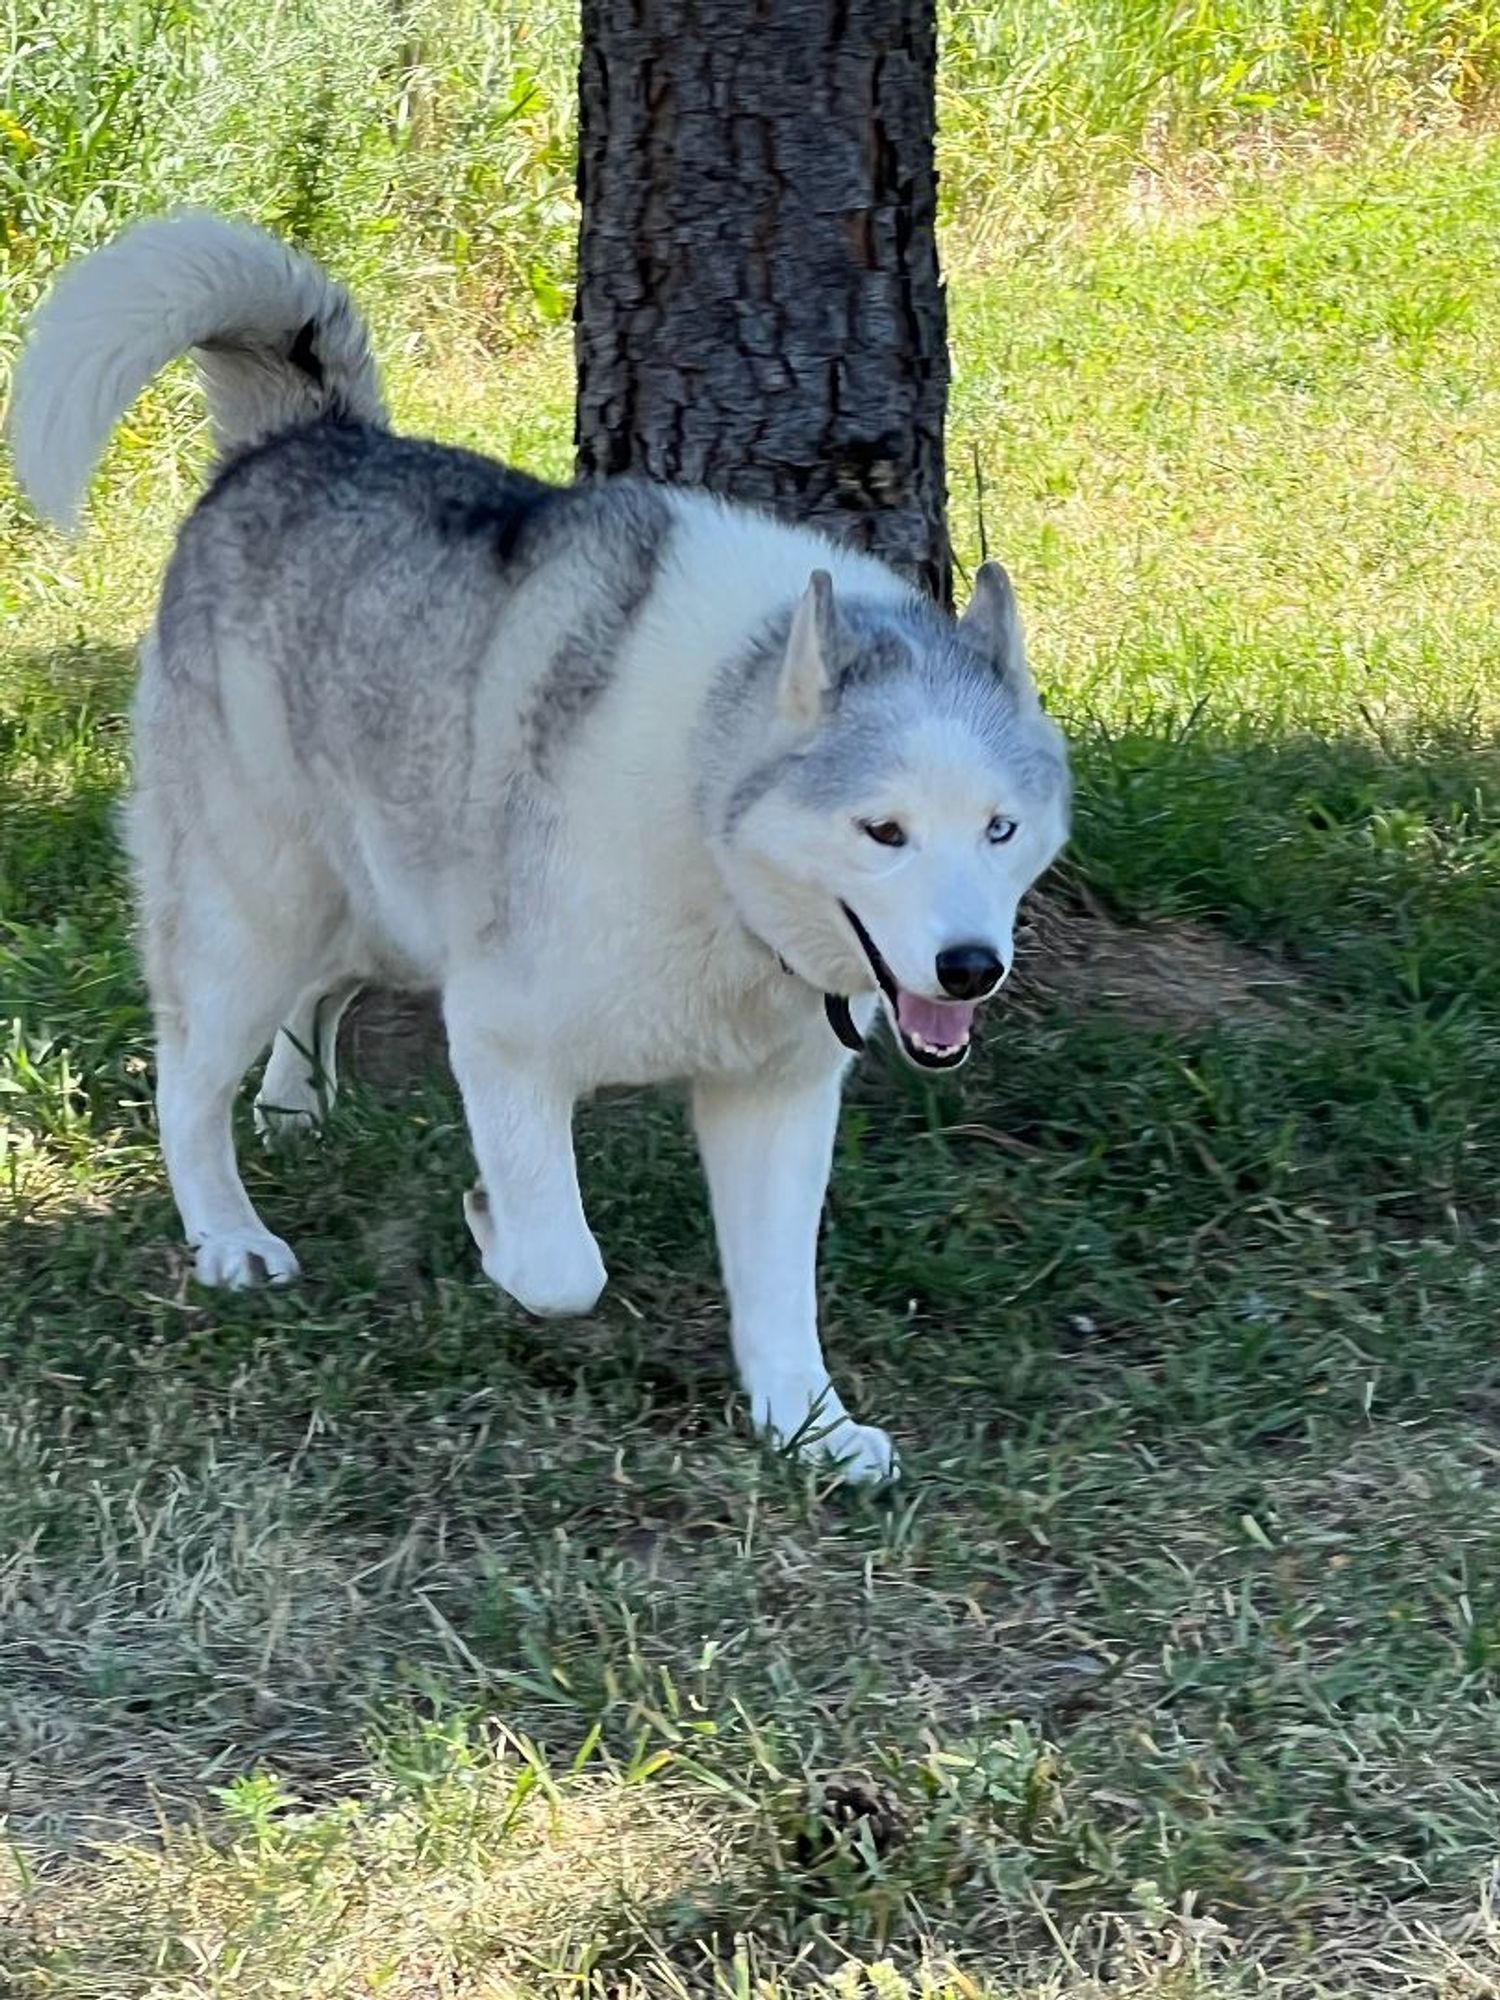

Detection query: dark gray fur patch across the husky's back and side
xmin=158 ymin=422 xmax=670 ymax=810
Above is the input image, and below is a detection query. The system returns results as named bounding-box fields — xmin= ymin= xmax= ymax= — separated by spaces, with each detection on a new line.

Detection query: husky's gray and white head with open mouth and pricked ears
xmin=718 ymin=562 xmax=1070 ymax=1068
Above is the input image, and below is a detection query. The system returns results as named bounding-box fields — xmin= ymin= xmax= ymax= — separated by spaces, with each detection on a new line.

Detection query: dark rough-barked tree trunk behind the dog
xmin=576 ymin=0 xmax=952 ymax=602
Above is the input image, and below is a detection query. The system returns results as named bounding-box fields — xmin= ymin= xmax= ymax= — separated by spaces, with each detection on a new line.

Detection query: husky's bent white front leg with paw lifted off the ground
xmin=444 ymin=994 xmax=604 ymax=1316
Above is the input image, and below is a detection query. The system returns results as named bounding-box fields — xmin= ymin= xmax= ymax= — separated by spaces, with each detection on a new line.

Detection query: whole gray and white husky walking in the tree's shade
xmin=12 ymin=212 xmax=1068 ymax=1480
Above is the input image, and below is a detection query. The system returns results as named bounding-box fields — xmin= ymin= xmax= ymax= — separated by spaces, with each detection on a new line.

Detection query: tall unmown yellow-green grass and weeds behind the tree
xmin=0 ymin=0 xmax=1500 ymax=354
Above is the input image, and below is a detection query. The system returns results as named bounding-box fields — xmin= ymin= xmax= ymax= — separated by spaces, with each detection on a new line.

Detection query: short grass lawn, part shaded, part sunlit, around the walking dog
xmin=0 ymin=8 xmax=1500 ymax=2000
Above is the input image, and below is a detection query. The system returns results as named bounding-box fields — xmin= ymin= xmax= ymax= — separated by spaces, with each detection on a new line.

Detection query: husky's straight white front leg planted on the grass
xmin=692 ymin=1072 xmax=896 ymax=1480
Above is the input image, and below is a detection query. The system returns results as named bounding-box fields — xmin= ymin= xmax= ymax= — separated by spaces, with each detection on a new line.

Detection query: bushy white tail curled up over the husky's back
xmin=10 ymin=210 xmax=386 ymax=526
